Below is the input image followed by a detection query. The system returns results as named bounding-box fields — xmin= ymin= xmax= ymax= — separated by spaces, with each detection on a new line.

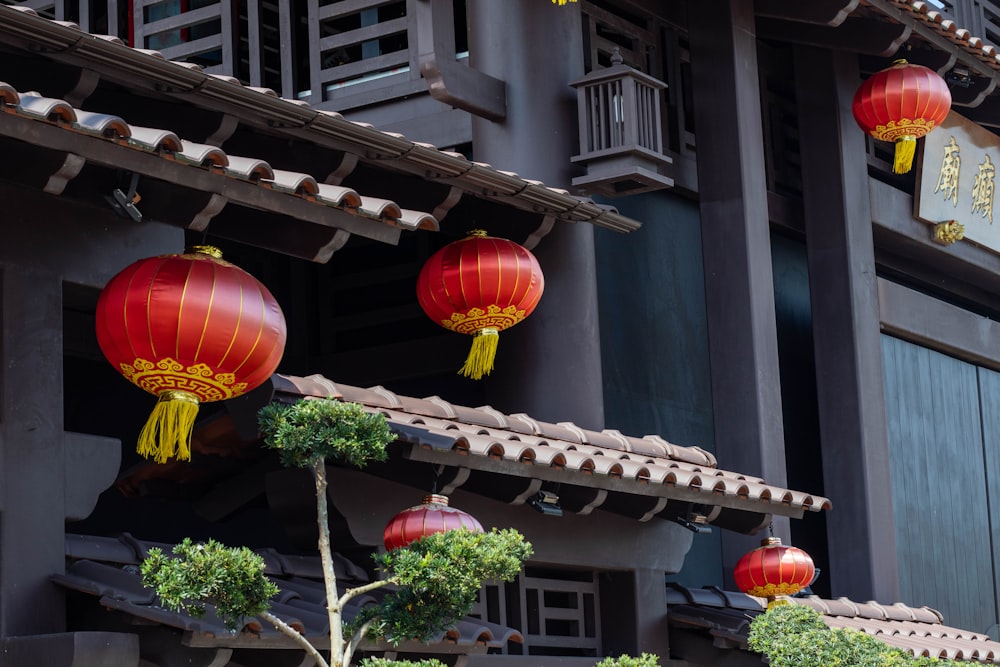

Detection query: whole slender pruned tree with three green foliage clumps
xmin=142 ymin=399 xmax=532 ymax=667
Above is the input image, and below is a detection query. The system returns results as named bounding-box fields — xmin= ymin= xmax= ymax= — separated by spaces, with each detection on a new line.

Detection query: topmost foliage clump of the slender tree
xmin=257 ymin=399 xmax=393 ymax=468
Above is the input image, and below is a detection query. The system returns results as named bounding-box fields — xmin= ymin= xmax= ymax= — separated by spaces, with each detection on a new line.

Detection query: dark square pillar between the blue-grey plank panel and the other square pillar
xmin=794 ymin=48 xmax=899 ymax=600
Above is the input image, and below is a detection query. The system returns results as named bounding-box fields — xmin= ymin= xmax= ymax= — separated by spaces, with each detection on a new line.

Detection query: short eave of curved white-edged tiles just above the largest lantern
xmin=0 ymin=81 xmax=438 ymax=261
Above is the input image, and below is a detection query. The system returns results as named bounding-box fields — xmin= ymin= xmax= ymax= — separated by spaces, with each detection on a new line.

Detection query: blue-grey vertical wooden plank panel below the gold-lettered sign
xmin=882 ymin=336 xmax=1000 ymax=632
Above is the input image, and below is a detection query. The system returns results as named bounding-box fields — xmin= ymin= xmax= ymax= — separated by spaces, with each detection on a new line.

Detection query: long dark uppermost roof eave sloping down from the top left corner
xmin=0 ymin=5 xmax=640 ymax=232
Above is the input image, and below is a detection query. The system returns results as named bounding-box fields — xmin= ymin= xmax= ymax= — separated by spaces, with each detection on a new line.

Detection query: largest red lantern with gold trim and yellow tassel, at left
xmin=97 ymin=246 xmax=286 ymax=463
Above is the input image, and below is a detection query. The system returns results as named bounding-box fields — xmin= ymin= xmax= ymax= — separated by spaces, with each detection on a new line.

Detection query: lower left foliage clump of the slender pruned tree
xmin=142 ymin=538 xmax=278 ymax=630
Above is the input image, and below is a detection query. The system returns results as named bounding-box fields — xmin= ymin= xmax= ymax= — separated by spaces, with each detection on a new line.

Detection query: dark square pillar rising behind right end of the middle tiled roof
xmin=687 ymin=0 xmax=790 ymax=572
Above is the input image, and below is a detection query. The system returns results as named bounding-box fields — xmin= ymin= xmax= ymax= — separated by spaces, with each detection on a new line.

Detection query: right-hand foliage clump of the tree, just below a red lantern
xmin=357 ymin=529 xmax=532 ymax=644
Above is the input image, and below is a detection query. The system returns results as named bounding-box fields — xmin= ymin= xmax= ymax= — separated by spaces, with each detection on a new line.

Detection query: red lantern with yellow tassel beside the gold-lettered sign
xmin=852 ymin=60 xmax=951 ymax=174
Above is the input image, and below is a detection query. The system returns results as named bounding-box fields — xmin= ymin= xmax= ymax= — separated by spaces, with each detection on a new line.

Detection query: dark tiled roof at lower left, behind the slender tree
xmin=52 ymin=534 xmax=523 ymax=652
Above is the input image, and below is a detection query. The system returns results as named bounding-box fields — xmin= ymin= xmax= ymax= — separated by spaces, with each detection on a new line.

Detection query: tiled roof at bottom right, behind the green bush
xmin=667 ymin=584 xmax=1000 ymax=664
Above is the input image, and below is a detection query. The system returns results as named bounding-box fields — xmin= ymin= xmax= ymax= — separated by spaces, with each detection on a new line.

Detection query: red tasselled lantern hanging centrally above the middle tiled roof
xmin=417 ymin=229 xmax=545 ymax=380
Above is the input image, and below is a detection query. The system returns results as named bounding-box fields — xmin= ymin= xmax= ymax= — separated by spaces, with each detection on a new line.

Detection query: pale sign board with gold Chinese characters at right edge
xmin=913 ymin=111 xmax=1000 ymax=254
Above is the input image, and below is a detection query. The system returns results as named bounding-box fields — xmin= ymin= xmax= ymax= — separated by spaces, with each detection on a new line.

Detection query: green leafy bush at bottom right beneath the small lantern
xmin=747 ymin=604 xmax=965 ymax=667
